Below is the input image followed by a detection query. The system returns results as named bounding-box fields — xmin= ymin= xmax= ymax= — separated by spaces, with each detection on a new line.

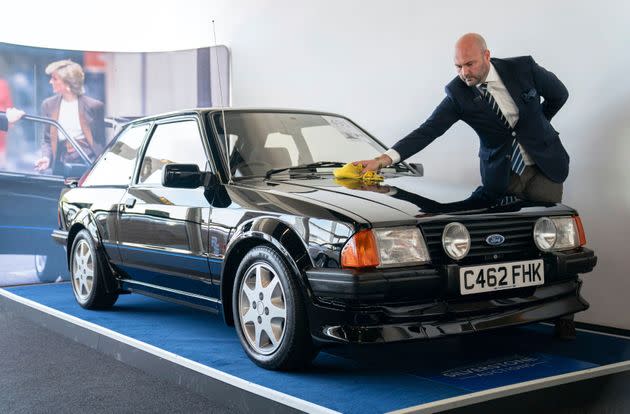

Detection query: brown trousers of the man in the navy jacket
xmin=507 ymin=165 xmax=563 ymax=203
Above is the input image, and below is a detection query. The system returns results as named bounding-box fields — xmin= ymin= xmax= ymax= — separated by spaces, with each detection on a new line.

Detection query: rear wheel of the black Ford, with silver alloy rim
xmin=70 ymin=230 xmax=118 ymax=309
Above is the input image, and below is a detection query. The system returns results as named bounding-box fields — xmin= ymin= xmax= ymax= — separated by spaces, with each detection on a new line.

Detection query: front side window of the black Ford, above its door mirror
xmin=138 ymin=120 xmax=207 ymax=184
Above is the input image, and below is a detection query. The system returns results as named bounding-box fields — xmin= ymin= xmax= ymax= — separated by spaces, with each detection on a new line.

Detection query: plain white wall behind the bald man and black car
xmin=0 ymin=0 xmax=630 ymax=329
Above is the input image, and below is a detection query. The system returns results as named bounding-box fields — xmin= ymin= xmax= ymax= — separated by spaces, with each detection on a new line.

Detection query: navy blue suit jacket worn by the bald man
xmin=392 ymin=56 xmax=569 ymax=194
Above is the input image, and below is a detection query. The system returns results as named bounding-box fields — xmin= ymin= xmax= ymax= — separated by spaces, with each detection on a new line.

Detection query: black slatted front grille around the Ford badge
xmin=420 ymin=217 xmax=539 ymax=264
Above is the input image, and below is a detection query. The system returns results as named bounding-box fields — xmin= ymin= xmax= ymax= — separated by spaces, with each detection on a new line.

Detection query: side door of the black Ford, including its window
xmin=118 ymin=117 xmax=219 ymax=308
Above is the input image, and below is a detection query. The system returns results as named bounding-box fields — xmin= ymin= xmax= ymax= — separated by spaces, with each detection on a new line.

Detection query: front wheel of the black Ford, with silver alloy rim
xmin=232 ymin=246 xmax=317 ymax=370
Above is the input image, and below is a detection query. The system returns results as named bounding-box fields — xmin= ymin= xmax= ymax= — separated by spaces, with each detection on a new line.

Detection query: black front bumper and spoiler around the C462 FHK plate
xmin=307 ymin=249 xmax=597 ymax=343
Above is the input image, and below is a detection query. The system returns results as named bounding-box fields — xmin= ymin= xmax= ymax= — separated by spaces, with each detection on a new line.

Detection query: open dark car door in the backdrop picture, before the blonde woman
xmin=0 ymin=115 xmax=91 ymax=285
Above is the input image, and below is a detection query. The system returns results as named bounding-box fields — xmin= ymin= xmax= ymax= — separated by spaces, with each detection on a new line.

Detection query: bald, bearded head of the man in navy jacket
xmin=455 ymin=33 xmax=490 ymax=86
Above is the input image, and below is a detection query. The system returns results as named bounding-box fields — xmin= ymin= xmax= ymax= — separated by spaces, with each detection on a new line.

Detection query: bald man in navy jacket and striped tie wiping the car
xmin=355 ymin=33 xmax=575 ymax=339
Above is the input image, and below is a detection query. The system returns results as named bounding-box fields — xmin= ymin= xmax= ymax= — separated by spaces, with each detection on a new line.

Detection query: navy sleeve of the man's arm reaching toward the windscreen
xmin=392 ymin=96 xmax=460 ymax=160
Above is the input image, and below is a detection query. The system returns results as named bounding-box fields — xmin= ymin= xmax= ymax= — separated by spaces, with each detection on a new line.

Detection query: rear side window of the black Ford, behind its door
xmin=83 ymin=124 xmax=149 ymax=186
